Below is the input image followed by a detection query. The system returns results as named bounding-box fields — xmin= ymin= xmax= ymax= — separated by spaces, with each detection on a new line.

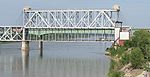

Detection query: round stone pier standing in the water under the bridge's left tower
xmin=21 ymin=41 xmax=29 ymax=56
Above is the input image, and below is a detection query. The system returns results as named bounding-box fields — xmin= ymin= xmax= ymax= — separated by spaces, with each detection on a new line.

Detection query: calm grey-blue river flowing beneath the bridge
xmin=0 ymin=42 xmax=111 ymax=77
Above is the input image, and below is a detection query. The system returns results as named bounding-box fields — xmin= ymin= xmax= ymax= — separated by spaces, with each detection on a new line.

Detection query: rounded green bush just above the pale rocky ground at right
xmin=130 ymin=48 xmax=145 ymax=68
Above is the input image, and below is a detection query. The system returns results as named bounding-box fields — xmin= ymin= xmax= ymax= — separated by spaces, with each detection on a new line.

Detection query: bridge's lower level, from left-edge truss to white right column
xmin=0 ymin=26 xmax=114 ymax=42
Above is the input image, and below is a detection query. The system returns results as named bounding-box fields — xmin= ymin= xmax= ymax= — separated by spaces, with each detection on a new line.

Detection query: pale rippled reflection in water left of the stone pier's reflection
xmin=0 ymin=56 xmax=22 ymax=77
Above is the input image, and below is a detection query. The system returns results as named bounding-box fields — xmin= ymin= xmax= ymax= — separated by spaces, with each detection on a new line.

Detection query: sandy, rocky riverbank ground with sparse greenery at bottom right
xmin=108 ymin=51 xmax=148 ymax=77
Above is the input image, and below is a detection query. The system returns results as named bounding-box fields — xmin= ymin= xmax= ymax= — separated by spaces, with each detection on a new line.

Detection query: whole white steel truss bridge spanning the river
xmin=0 ymin=8 xmax=127 ymax=41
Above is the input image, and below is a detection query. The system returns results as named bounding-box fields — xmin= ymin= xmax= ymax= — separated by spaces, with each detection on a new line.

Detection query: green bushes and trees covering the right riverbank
xmin=107 ymin=30 xmax=150 ymax=77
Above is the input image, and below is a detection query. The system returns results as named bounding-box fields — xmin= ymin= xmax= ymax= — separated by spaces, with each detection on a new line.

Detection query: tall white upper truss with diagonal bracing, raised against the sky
xmin=23 ymin=9 xmax=118 ymax=28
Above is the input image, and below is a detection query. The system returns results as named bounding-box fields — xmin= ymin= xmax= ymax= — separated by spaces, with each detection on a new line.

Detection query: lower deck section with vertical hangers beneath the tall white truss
xmin=26 ymin=28 xmax=114 ymax=41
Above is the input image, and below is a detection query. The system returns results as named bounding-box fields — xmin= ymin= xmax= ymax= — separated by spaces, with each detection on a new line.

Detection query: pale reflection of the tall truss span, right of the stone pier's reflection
xmin=29 ymin=57 xmax=109 ymax=77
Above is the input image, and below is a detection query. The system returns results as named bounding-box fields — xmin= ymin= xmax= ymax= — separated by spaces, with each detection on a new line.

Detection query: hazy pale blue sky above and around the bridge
xmin=0 ymin=0 xmax=150 ymax=28
